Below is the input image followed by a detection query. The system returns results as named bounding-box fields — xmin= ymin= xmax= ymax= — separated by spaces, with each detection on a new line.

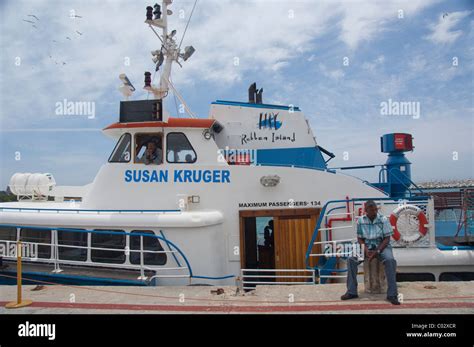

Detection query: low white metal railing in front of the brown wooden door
xmin=240 ymin=269 xmax=316 ymax=289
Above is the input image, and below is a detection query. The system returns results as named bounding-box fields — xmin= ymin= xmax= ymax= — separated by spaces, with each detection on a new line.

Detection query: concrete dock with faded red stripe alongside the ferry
xmin=0 ymin=281 xmax=474 ymax=314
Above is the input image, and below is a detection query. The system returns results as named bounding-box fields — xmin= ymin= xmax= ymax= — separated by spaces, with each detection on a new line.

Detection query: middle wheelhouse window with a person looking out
xmin=135 ymin=133 xmax=163 ymax=165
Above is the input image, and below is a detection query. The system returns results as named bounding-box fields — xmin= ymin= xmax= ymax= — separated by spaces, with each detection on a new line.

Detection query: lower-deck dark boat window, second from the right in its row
xmin=91 ymin=229 xmax=125 ymax=264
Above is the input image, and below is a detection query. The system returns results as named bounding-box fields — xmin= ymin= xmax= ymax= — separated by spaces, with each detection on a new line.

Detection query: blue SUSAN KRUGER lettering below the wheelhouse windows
xmin=124 ymin=170 xmax=230 ymax=183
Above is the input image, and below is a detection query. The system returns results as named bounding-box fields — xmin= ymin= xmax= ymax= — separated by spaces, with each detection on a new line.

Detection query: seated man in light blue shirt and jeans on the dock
xmin=341 ymin=200 xmax=400 ymax=305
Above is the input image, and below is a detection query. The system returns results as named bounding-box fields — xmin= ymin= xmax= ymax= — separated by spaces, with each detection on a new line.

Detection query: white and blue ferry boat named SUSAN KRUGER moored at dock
xmin=0 ymin=0 xmax=474 ymax=289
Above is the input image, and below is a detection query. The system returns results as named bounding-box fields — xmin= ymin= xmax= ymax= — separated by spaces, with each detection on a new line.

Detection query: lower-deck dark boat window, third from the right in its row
xmin=58 ymin=229 xmax=87 ymax=261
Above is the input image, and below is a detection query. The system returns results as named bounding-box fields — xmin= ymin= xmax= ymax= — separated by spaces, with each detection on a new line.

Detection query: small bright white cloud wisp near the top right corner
xmin=425 ymin=11 xmax=471 ymax=44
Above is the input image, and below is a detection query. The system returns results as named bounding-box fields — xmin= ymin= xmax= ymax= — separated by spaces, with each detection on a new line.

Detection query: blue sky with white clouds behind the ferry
xmin=0 ymin=0 xmax=474 ymax=190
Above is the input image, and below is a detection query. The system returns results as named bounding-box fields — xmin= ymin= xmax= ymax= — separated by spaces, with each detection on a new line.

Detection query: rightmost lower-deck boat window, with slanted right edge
xmin=130 ymin=230 xmax=167 ymax=265
